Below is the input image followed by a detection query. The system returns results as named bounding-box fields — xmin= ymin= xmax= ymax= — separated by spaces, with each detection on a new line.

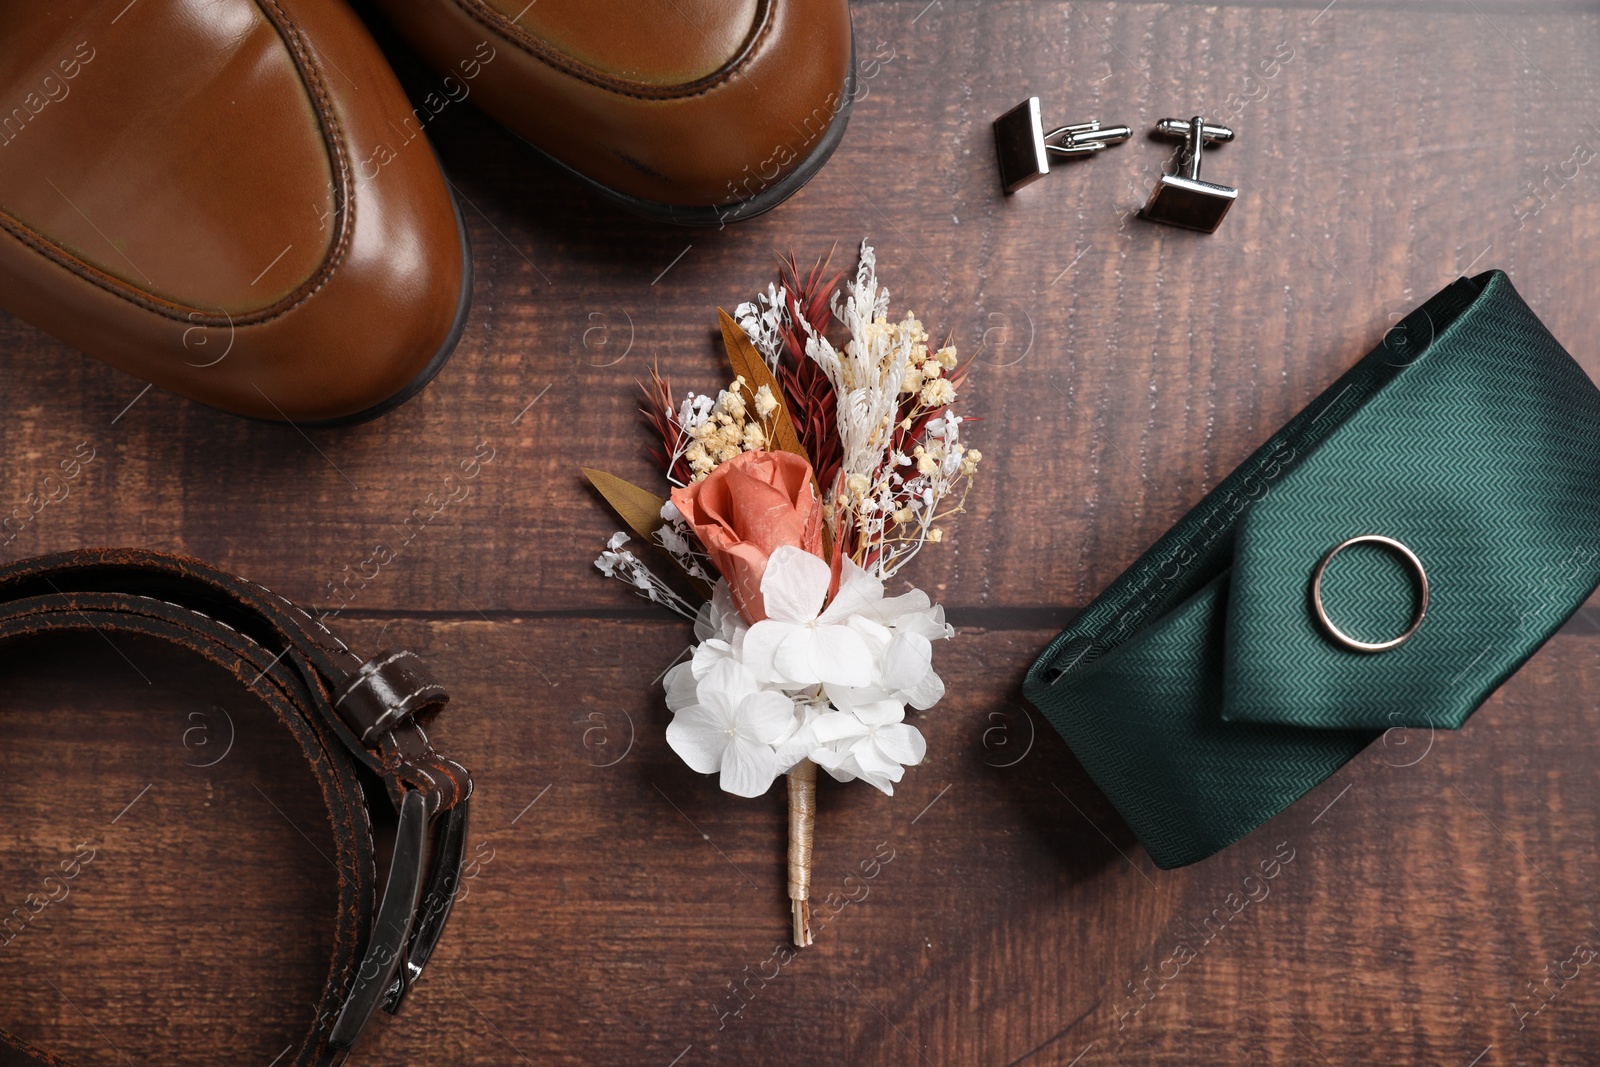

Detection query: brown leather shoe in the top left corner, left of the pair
xmin=0 ymin=0 xmax=472 ymax=422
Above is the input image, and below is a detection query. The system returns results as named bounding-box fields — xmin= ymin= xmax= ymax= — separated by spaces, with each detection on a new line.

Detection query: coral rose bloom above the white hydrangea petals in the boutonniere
xmin=672 ymin=451 xmax=822 ymax=624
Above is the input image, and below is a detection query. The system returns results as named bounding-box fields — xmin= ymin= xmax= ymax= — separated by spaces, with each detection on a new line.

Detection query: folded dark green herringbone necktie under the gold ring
xmin=1026 ymin=270 xmax=1600 ymax=867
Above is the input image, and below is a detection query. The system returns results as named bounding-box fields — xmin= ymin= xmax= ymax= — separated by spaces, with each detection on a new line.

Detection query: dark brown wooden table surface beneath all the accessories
xmin=0 ymin=0 xmax=1600 ymax=1067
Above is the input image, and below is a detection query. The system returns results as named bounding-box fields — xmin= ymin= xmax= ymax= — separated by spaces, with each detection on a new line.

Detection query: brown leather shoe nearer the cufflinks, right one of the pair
xmin=376 ymin=0 xmax=854 ymax=226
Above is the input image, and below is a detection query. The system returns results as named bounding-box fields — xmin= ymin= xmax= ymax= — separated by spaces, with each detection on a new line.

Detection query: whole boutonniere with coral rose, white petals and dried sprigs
xmin=584 ymin=243 xmax=982 ymax=947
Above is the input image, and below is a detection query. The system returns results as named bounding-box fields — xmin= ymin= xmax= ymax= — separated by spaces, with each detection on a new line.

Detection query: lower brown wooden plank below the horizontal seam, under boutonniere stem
xmin=0 ymin=619 xmax=1600 ymax=1064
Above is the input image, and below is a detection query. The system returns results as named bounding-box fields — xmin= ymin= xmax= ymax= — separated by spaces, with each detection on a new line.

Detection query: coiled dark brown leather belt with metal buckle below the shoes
xmin=0 ymin=549 xmax=472 ymax=1067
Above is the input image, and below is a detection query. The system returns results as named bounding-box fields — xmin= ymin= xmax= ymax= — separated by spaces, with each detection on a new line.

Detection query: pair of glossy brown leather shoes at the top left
xmin=0 ymin=0 xmax=853 ymax=422
